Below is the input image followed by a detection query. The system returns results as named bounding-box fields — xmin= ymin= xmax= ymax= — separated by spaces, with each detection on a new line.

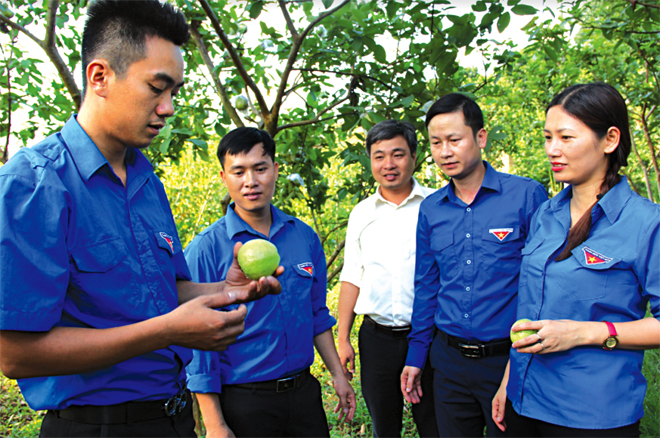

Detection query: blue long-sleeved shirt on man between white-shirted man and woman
xmin=406 ymin=161 xmax=548 ymax=368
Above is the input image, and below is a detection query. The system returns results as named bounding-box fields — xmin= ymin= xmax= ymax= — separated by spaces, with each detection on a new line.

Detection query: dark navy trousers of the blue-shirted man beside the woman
xmin=430 ymin=335 xmax=509 ymax=437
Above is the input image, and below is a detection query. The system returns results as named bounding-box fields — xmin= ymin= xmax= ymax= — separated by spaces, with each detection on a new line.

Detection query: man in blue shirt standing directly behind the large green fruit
xmin=185 ymin=128 xmax=355 ymax=437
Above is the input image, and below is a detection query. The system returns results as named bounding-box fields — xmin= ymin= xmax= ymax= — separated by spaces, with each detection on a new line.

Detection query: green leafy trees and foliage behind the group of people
xmin=0 ymin=0 xmax=660 ymax=436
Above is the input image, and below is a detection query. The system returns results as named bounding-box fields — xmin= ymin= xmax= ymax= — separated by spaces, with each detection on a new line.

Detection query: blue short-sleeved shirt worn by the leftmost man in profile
xmin=0 ymin=117 xmax=190 ymax=409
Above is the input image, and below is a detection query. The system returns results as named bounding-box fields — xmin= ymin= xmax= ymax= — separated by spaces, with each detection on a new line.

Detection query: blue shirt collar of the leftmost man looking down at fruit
xmin=60 ymin=114 xmax=153 ymax=185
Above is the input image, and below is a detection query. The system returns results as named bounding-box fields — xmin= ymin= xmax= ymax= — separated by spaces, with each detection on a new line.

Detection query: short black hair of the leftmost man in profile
xmin=82 ymin=0 xmax=190 ymax=99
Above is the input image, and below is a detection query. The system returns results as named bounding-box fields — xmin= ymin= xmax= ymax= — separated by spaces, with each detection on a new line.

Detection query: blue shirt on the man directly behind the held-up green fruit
xmin=185 ymin=204 xmax=336 ymax=393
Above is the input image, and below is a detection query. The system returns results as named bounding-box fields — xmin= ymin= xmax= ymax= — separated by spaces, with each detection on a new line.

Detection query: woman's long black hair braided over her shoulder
xmin=545 ymin=82 xmax=632 ymax=261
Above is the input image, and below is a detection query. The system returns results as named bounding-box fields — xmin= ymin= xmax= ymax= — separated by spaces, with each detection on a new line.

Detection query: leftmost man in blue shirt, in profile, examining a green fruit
xmin=0 ymin=0 xmax=281 ymax=436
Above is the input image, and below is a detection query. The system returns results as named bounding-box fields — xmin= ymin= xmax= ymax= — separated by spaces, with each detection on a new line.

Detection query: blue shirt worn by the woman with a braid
xmin=507 ymin=178 xmax=660 ymax=429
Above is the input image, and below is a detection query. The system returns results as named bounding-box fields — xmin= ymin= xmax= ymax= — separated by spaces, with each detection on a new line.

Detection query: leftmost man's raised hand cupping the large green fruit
xmin=224 ymin=243 xmax=284 ymax=303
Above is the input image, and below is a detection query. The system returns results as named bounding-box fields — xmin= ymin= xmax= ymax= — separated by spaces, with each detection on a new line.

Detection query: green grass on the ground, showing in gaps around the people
xmin=0 ymin=287 xmax=660 ymax=438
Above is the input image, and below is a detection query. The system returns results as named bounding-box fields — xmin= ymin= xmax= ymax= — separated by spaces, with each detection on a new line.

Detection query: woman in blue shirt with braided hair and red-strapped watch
xmin=492 ymin=83 xmax=660 ymax=436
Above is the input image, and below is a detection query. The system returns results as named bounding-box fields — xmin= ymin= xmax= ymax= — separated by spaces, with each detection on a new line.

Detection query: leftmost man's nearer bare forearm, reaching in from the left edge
xmin=0 ymin=317 xmax=169 ymax=379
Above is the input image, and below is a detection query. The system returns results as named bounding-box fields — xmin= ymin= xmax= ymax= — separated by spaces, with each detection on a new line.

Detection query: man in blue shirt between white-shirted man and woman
xmin=401 ymin=93 xmax=548 ymax=437
